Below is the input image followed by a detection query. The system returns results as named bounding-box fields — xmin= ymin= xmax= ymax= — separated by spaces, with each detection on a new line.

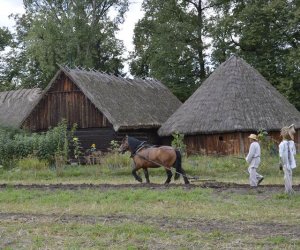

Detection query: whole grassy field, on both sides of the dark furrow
xmin=0 ymin=155 xmax=300 ymax=249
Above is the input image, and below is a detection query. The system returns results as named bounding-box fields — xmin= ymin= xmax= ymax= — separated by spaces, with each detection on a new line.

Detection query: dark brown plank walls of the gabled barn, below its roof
xmin=22 ymin=73 xmax=162 ymax=151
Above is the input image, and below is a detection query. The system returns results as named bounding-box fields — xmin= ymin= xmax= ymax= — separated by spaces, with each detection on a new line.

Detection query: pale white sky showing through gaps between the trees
xmin=0 ymin=0 xmax=144 ymax=72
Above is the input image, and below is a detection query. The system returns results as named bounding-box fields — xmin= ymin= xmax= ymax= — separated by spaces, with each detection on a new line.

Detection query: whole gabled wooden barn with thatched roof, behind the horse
xmin=22 ymin=67 xmax=181 ymax=150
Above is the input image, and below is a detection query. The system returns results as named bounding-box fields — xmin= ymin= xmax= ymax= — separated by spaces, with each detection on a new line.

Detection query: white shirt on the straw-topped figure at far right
xmin=279 ymin=140 xmax=296 ymax=169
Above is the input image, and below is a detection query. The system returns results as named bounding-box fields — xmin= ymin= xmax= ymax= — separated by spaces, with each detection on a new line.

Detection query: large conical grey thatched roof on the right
xmin=158 ymin=56 xmax=300 ymax=136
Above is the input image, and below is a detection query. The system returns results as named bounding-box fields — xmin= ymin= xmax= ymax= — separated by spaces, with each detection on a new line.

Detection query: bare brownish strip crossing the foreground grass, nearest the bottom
xmin=0 ymin=213 xmax=300 ymax=239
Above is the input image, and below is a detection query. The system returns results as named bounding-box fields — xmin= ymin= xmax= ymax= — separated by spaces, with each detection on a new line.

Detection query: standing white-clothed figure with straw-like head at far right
xmin=279 ymin=124 xmax=296 ymax=194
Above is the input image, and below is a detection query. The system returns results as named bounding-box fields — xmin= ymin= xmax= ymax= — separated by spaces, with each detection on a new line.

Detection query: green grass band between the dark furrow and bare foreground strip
xmin=0 ymin=188 xmax=300 ymax=224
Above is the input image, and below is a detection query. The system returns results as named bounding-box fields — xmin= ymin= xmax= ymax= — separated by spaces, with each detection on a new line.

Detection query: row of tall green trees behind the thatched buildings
xmin=0 ymin=0 xmax=300 ymax=110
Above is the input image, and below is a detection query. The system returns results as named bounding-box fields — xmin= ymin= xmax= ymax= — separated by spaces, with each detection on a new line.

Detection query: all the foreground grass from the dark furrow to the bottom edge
xmin=0 ymin=188 xmax=300 ymax=249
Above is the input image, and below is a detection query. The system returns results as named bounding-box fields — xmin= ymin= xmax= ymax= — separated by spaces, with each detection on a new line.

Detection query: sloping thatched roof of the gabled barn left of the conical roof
xmin=24 ymin=66 xmax=182 ymax=131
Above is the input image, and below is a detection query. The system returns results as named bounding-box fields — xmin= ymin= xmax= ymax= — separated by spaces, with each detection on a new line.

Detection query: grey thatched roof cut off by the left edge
xmin=0 ymin=88 xmax=42 ymax=128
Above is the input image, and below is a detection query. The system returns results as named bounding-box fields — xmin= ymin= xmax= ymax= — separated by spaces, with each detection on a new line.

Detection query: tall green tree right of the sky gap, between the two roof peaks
xmin=130 ymin=0 xmax=213 ymax=101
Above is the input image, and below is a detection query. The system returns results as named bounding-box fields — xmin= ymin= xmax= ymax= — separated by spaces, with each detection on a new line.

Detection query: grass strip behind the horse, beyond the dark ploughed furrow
xmin=0 ymin=155 xmax=300 ymax=184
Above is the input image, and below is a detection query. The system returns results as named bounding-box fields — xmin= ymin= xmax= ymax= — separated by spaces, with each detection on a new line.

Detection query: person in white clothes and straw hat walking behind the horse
xmin=246 ymin=134 xmax=264 ymax=187
